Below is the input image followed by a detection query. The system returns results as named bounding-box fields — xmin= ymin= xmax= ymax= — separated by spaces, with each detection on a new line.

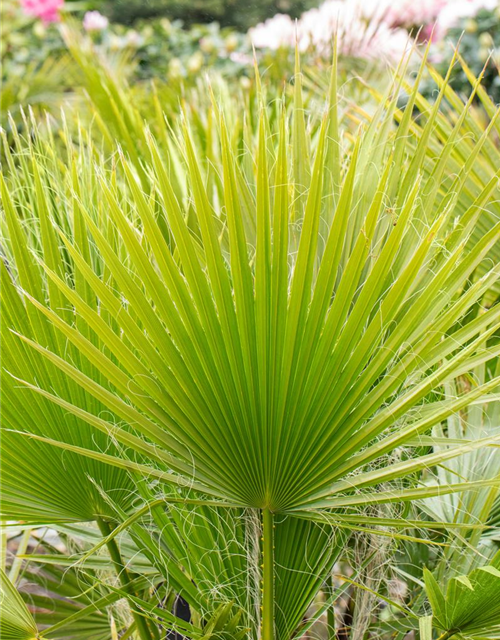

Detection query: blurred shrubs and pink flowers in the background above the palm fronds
xmin=0 ymin=0 xmax=500 ymax=128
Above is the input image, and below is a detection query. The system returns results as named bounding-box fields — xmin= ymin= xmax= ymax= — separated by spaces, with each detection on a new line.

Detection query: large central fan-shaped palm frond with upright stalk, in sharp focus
xmin=3 ymin=46 xmax=500 ymax=640
